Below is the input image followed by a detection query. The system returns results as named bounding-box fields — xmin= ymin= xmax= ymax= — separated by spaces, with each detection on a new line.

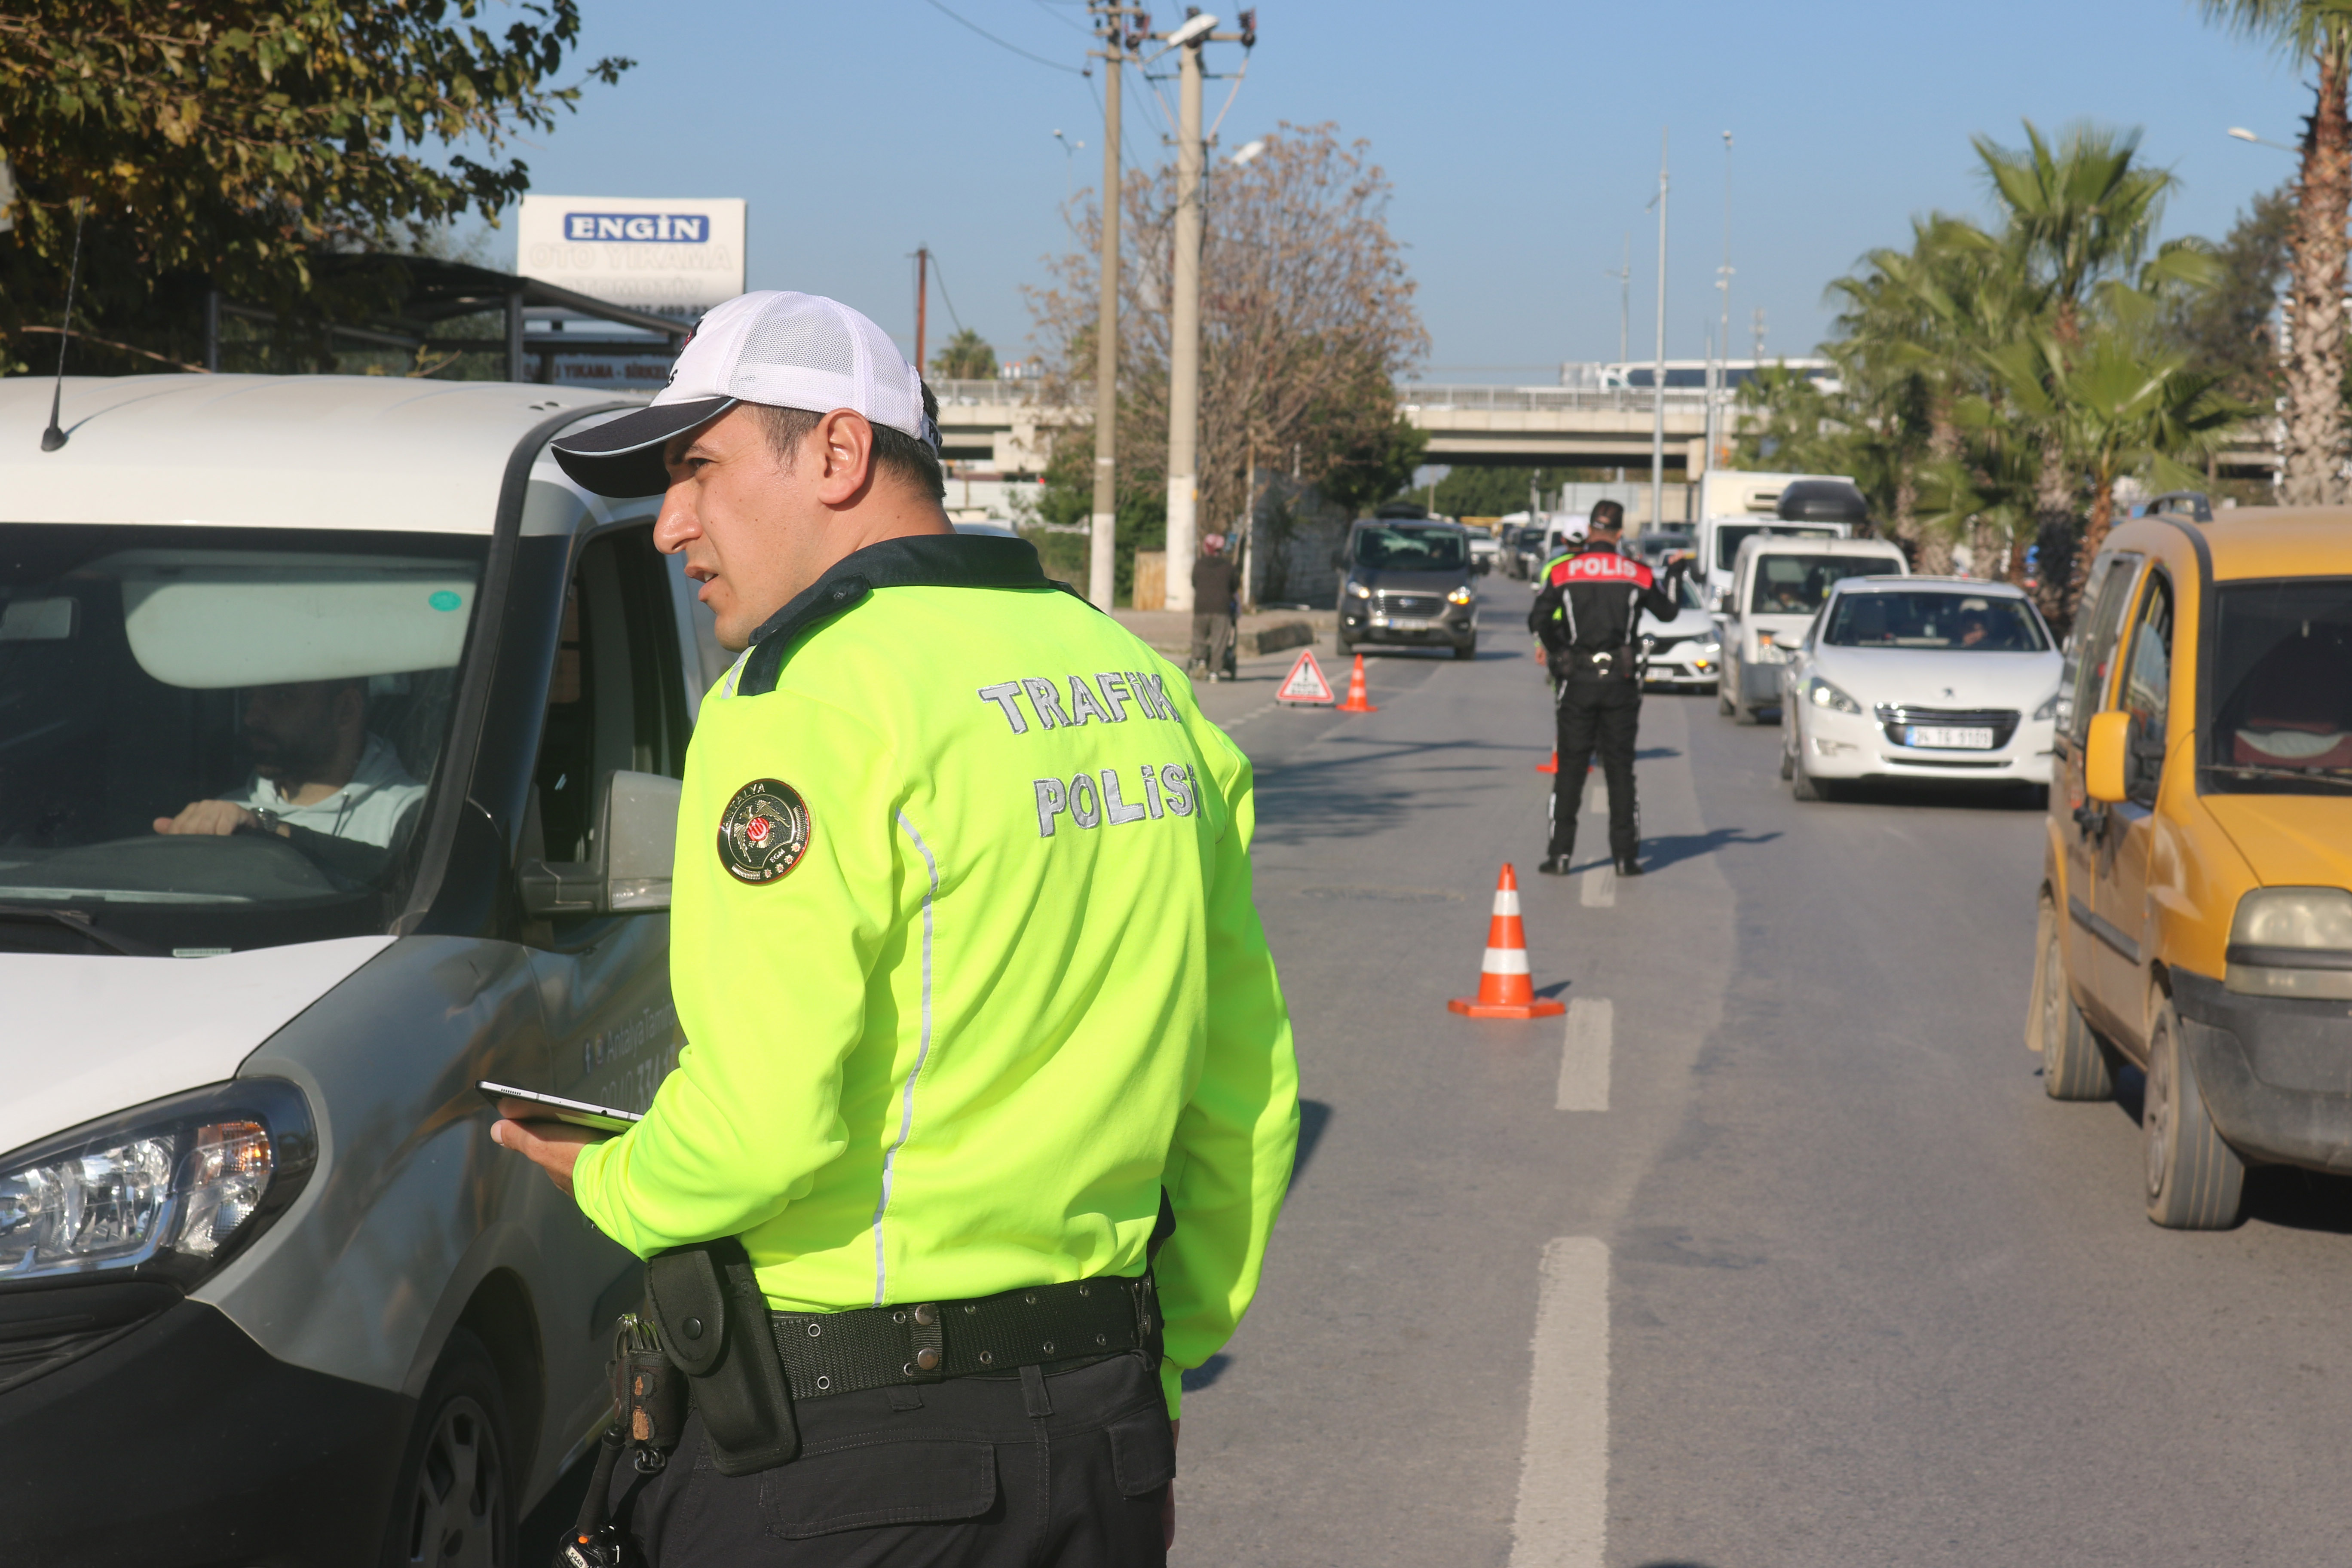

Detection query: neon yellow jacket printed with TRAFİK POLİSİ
xmin=574 ymin=536 xmax=1298 ymax=1415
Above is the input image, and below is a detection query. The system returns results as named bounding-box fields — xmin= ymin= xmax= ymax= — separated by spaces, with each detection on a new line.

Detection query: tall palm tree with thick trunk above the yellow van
xmin=2199 ymin=0 xmax=2352 ymax=505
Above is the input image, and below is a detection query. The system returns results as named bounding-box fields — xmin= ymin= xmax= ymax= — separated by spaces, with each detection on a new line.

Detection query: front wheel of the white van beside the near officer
xmin=383 ymin=1328 xmax=515 ymax=1568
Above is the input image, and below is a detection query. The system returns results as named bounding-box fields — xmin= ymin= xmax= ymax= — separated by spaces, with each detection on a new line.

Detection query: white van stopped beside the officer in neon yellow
xmin=0 ymin=376 xmax=727 ymax=1563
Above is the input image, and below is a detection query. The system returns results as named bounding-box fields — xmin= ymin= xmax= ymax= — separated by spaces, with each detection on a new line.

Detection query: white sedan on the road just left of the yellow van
xmin=1780 ymin=576 xmax=2058 ymax=799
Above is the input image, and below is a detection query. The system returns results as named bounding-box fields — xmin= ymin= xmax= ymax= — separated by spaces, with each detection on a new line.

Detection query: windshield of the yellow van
xmin=2199 ymin=578 xmax=2352 ymax=795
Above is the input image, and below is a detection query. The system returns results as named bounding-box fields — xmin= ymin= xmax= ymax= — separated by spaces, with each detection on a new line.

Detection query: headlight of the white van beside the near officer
xmin=0 ymin=1079 xmax=318 ymax=1288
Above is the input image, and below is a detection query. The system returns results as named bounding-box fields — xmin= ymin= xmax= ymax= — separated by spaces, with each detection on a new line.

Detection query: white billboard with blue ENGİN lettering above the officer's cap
xmin=515 ymin=195 xmax=743 ymax=320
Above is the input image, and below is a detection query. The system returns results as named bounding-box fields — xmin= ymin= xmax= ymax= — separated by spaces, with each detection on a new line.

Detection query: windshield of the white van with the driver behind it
xmin=0 ymin=524 xmax=487 ymax=957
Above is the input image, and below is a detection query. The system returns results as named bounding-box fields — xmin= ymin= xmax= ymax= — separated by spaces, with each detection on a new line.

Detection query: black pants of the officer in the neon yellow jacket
xmin=614 ymin=1354 xmax=1176 ymax=1568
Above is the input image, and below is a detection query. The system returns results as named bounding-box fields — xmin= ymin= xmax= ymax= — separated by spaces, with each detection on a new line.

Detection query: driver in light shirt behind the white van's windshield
xmin=155 ymin=677 xmax=426 ymax=875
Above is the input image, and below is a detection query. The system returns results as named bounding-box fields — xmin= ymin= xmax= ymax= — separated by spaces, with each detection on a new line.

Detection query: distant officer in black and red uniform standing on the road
xmin=1526 ymin=501 xmax=1679 ymax=877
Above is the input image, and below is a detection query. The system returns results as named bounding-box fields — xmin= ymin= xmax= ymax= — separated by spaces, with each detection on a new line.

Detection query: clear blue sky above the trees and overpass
xmin=487 ymin=0 xmax=2310 ymax=383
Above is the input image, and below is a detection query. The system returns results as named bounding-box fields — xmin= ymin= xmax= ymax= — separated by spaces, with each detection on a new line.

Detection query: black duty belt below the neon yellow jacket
xmin=769 ymin=1274 xmax=1160 ymax=1399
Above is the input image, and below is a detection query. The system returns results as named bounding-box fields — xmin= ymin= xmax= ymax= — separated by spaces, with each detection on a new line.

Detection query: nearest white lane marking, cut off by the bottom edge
xmin=1510 ymin=1237 xmax=1609 ymax=1568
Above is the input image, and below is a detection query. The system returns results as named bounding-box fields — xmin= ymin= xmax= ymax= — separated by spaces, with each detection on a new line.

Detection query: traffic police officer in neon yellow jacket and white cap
xmin=496 ymin=291 xmax=1298 ymax=1566
